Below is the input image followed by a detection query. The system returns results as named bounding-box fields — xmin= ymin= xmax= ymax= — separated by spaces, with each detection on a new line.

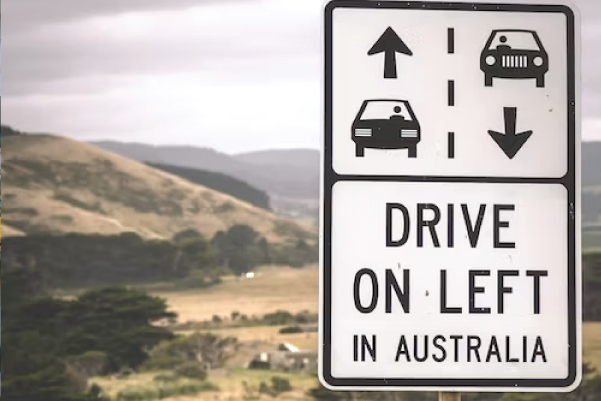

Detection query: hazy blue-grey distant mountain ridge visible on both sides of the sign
xmin=91 ymin=138 xmax=601 ymax=247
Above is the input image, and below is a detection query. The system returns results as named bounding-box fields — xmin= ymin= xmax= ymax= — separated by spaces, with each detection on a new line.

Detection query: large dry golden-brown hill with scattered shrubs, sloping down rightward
xmin=2 ymin=135 xmax=315 ymax=243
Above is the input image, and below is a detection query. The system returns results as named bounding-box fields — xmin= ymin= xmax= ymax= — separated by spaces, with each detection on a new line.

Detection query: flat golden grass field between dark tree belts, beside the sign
xmin=155 ymin=266 xmax=319 ymax=323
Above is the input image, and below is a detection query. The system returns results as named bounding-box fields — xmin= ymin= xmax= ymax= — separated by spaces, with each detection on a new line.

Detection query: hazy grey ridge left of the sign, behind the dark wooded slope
xmin=92 ymin=141 xmax=319 ymax=199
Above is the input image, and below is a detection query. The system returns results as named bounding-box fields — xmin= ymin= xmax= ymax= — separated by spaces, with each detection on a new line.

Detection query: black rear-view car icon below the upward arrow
xmin=351 ymin=99 xmax=421 ymax=158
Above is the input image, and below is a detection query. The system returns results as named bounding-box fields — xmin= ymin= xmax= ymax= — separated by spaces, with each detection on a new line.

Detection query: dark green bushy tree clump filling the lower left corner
xmin=2 ymin=269 xmax=175 ymax=401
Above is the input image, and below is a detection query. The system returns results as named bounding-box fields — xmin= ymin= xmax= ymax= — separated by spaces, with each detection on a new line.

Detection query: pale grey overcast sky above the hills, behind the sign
xmin=1 ymin=0 xmax=601 ymax=153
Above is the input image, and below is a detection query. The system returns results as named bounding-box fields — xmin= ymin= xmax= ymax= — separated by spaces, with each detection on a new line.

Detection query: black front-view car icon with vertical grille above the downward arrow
xmin=480 ymin=29 xmax=549 ymax=88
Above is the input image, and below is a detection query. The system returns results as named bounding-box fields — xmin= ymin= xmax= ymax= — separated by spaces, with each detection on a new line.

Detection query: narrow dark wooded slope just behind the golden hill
xmin=147 ymin=163 xmax=270 ymax=210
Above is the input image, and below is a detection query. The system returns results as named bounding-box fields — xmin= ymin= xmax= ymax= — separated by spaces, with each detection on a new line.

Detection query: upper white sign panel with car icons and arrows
xmin=326 ymin=2 xmax=576 ymax=179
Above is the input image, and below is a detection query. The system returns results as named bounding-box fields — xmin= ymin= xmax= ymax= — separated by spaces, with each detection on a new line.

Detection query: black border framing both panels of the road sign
xmin=320 ymin=0 xmax=580 ymax=391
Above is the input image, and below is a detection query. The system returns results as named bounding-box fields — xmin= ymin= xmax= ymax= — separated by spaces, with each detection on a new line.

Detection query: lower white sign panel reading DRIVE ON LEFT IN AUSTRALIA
xmin=321 ymin=181 xmax=579 ymax=391
